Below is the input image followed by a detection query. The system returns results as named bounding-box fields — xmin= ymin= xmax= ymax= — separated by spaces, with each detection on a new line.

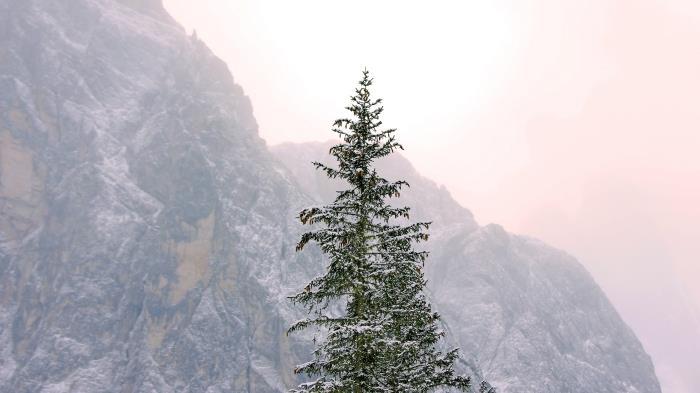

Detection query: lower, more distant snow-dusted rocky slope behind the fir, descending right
xmin=272 ymin=143 xmax=660 ymax=393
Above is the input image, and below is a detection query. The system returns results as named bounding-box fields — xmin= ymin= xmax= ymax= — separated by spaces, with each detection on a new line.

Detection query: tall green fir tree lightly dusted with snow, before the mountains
xmin=289 ymin=70 xmax=490 ymax=393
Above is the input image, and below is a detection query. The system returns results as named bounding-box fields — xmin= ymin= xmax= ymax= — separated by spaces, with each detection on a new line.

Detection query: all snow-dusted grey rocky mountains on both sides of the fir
xmin=0 ymin=0 xmax=659 ymax=393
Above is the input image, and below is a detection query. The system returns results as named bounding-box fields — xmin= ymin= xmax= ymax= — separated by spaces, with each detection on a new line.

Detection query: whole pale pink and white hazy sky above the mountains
xmin=164 ymin=0 xmax=700 ymax=393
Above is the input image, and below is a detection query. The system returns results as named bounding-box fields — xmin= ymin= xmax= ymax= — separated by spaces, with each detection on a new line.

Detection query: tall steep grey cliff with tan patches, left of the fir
xmin=0 ymin=0 xmax=318 ymax=392
